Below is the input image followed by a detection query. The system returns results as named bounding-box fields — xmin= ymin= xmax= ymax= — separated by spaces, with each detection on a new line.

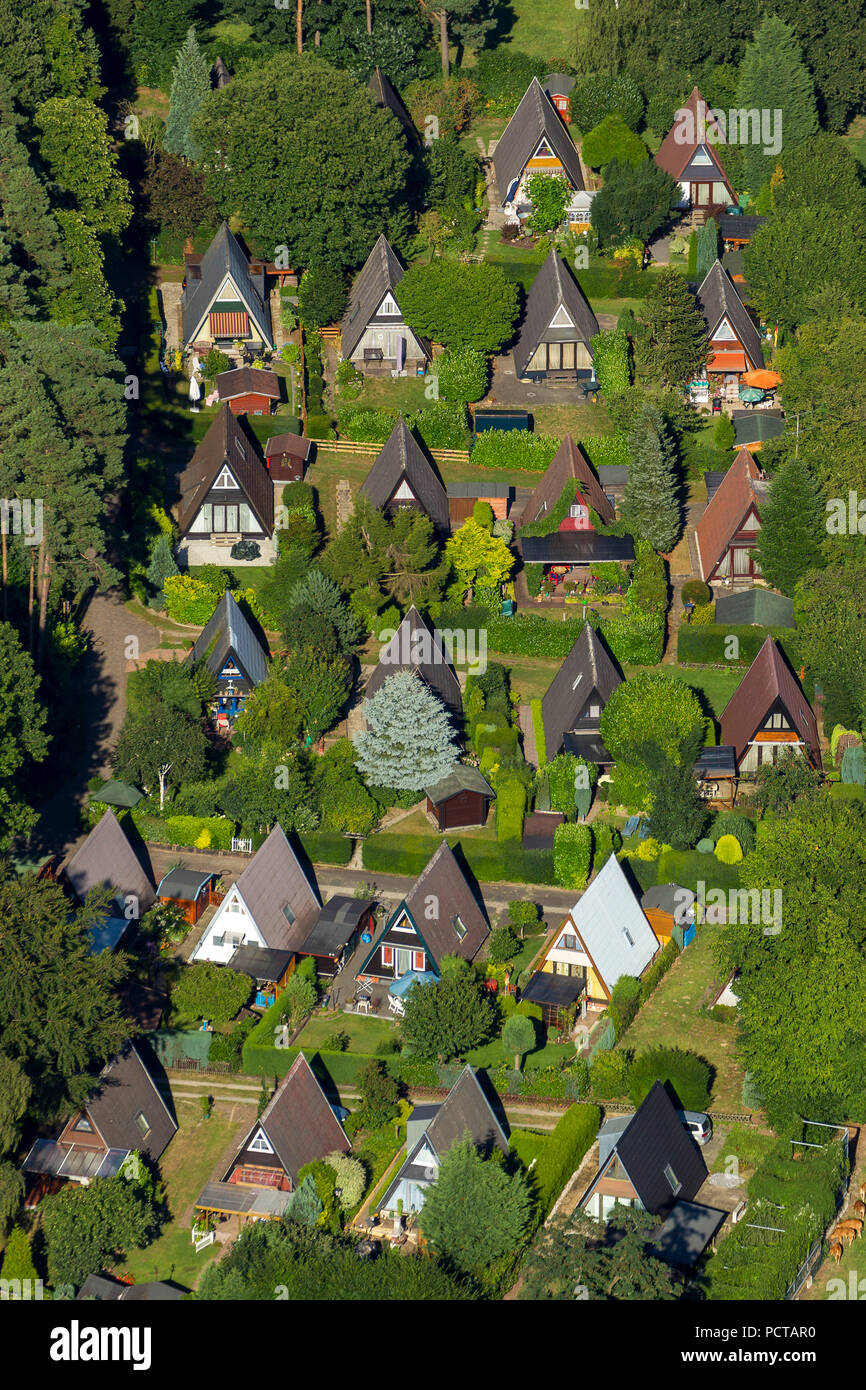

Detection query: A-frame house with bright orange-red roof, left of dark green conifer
xmin=695 ymin=449 xmax=769 ymax=584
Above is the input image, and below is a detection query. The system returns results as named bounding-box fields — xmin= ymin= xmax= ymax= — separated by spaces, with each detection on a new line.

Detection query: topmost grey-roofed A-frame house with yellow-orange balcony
xmin=493 ymin=78 xmax=591 ymax=227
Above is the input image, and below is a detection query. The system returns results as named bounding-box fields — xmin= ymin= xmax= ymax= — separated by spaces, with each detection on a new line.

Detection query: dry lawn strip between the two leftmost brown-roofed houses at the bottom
xmin=113 ymin=1099 xmax=248 ymax=1289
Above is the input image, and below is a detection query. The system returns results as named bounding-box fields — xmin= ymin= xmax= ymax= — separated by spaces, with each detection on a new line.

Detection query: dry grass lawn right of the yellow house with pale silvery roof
xmin=621 ymin=928 xmax=748 ymax=1111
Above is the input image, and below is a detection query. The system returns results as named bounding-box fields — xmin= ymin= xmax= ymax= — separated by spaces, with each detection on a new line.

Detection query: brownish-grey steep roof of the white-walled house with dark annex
xmin=235 ymin=824 xmax=321 ymax=951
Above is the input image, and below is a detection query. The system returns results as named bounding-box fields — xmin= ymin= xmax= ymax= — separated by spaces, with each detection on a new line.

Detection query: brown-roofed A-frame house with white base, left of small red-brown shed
xmin=177 ymin=402 xmax=275 ymax=564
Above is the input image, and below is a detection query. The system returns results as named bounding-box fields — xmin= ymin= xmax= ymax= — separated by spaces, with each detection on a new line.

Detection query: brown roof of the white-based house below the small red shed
xmin=178 ymin=400 xmax=274 ymax=535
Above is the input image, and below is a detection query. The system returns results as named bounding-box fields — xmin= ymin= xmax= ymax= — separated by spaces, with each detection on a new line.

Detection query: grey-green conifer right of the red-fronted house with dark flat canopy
xmin=623 ymin=404 xmax=681 ymax=553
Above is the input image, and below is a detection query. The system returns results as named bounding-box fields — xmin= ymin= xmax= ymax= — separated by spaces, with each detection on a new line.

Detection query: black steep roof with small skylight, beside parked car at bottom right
xmin=616 ymin=1081 xmax=708 ymax=1215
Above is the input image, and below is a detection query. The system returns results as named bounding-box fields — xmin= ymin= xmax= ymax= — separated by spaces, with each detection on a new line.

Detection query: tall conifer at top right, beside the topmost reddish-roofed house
xmin=735 ymin=14 xmax=817 ymax=196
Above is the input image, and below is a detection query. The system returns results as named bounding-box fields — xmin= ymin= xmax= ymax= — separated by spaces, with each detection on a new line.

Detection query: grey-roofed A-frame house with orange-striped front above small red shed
xmin=181 ymin=222 xmax=274 ymax=352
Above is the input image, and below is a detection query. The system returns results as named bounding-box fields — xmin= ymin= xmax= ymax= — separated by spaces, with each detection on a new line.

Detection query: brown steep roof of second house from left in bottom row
xmin=240 ymin=1052 xmax=352 ymax=1184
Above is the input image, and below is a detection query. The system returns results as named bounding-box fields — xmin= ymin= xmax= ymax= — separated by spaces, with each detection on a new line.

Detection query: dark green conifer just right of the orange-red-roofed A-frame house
xmin=755 ymin=457 xmax=827 ymax=595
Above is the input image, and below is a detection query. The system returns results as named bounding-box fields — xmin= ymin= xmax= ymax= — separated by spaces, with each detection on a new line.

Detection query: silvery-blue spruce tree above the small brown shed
xmin=353 ymin=671 xmax=459 ymax=791
